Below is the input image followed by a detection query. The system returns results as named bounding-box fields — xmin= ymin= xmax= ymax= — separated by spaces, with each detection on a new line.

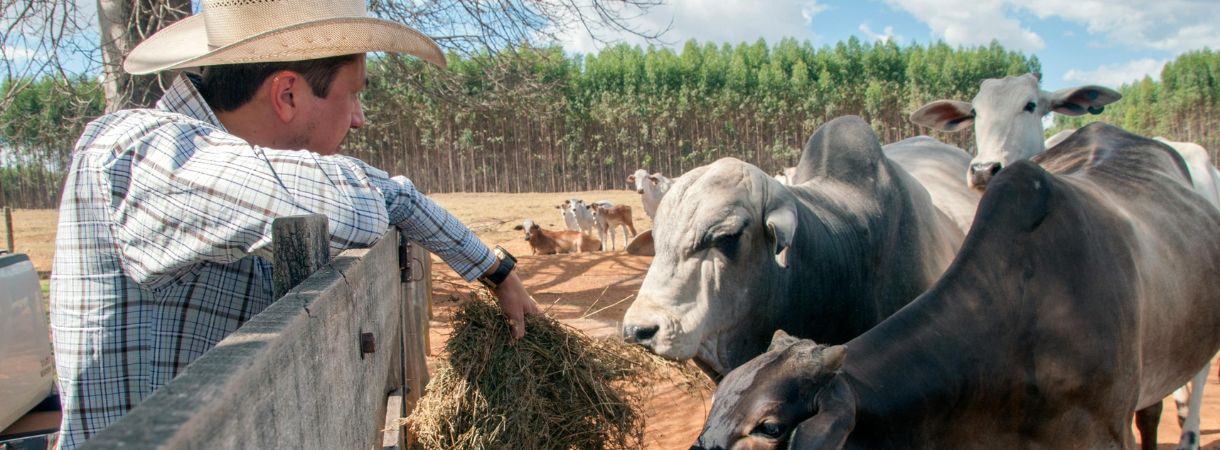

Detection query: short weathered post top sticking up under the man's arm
xmin=271 ymin=215 xmax=331 ymax=299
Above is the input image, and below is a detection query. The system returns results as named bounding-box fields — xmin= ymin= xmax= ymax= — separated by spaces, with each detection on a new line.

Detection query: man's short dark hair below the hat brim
xmin=199 ymin=54 xmax=360 ymax=112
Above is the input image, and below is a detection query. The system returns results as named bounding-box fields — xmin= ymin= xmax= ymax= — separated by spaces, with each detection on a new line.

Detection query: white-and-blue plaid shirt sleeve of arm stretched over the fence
xmin=106 ymin=117 xmax=494 ymax=285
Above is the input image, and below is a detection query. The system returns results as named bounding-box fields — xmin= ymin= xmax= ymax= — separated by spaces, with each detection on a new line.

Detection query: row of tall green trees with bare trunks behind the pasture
xmin=0 ymin=38 xmax=1220 ymax=207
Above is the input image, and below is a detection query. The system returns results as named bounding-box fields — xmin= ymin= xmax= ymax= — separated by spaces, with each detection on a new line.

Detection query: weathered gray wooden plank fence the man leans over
xmin=84 ymin=215 xmax=431 ymax=449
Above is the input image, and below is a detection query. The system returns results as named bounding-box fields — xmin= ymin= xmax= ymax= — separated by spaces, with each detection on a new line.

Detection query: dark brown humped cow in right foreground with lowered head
xmin=693 ymin=123 xmax=1220 ymax=449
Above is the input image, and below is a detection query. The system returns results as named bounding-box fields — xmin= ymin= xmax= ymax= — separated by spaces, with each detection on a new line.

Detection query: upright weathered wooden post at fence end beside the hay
xmin=398 ymin=239 xmax=432 ymax=449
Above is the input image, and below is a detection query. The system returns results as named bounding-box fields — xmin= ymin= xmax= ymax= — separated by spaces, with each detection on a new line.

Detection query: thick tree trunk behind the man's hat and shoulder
xmin=98 ymin=0 xmax=190 ymax=112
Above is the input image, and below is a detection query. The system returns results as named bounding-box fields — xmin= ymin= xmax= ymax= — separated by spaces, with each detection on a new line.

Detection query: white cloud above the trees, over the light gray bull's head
xmin=556 ymin=0 xmax=828 ymax=54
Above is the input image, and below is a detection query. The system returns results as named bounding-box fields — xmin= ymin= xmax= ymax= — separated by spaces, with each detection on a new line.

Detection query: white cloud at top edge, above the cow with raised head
xmin=886 ymin=0 xmax=1046 ymax=51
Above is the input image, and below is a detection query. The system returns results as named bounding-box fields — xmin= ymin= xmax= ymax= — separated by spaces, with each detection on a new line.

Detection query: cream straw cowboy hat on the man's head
xmin=123 ymin=0 xmax=445 ymax=74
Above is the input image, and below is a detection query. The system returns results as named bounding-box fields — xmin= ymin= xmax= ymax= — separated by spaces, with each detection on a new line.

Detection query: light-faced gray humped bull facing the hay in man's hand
xmin=623 ymin=117 xmax=975 ymax=374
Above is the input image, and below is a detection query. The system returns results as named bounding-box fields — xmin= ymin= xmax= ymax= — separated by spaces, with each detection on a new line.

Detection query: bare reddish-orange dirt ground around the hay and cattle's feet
xmin=429 ymin=251 xmax=1220 ymax=450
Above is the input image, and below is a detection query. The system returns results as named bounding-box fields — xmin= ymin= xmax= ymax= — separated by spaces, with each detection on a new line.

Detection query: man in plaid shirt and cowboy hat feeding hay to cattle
xmin=50 ymin=0 xmax=538 ymax=449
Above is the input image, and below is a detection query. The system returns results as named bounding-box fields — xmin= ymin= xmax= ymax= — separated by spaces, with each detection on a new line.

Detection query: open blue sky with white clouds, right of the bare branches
xmin=561 ymin=0 xmax=1220 ymax=90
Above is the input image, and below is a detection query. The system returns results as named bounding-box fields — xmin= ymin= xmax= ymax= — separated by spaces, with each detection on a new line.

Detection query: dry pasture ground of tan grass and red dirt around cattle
xmin=13 ymin=189 xmax=1220 ymax=449
